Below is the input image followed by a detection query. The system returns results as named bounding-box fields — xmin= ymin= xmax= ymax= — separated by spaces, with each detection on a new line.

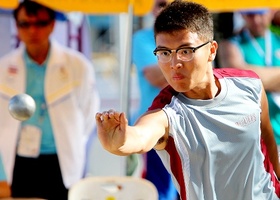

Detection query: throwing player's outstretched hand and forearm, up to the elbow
xmin=96 ymin=116 xmax=156 ymax=156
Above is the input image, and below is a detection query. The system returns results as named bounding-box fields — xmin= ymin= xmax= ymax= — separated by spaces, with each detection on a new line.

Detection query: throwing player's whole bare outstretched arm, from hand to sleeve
xmin=96 ymin=110 xmax=168 ymax=156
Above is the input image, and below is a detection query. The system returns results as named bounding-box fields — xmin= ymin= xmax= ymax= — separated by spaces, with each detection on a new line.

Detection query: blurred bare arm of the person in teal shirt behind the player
xmin=218 ymin=41 xmax=280 ymax=92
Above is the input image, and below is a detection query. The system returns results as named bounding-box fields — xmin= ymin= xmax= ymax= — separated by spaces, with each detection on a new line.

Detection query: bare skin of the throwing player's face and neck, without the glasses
xmin=156 ymin=30 xmax=220 ymax=99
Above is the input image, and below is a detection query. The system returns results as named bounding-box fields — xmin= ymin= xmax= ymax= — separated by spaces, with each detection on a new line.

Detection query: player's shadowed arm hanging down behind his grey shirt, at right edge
xmin=261 ymin=83 xmax=280 ymax=178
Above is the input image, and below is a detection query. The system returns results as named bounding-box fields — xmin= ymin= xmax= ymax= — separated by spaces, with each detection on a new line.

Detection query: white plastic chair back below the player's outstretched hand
xmin=68 ymin=176 xmax=158 ymax=200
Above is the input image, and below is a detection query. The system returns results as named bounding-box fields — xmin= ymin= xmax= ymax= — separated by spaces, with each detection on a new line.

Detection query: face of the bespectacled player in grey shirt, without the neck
xmin=156 ymin=30 xmax=217 ymax=97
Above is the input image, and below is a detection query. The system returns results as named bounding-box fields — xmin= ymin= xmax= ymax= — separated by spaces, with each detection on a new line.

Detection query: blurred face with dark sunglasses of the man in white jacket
xmin=16 ymin=8 xmax=54 ymax=48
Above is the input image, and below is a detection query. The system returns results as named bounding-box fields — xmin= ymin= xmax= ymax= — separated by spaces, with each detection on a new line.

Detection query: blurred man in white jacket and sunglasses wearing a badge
xmin=0 ymin=0 xmax=100 ymax=200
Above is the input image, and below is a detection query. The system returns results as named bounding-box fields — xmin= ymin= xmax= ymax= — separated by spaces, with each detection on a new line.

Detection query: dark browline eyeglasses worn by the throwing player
xmin=153 ymin=41 xmax=211 ymax=63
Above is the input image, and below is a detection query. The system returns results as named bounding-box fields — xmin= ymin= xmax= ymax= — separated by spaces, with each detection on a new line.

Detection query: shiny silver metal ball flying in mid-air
xmin=9 ymin=94 xmax=36 ymax=121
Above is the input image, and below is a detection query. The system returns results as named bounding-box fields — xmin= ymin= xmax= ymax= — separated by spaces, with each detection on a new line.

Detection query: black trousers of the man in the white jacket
xmin=11 ymin=155 xmax=68 ymax=200
